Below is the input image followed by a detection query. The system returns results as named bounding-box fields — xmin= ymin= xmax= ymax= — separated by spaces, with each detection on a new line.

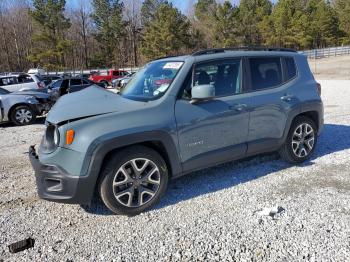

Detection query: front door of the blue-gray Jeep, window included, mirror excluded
xmin=175 ymin=59 xmax=249 ymax=172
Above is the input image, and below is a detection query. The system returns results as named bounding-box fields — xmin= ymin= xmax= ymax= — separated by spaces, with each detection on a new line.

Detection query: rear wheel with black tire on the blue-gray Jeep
xmin=279 ymin=116 xmax=317 ymax=164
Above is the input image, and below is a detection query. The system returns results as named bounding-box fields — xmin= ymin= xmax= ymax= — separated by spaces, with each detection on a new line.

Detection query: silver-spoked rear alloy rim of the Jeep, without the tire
xmin=292 ymin=123 xmax=315 ymax=158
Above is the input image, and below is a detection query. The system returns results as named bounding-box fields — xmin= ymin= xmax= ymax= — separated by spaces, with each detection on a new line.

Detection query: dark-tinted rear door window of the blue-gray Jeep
xmin=249 ymin=57 xmax=282 ymax=91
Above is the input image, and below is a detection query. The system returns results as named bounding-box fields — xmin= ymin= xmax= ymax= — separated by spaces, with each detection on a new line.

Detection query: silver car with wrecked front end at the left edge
xmin=0 ymin=88 xmax=53 ymax=125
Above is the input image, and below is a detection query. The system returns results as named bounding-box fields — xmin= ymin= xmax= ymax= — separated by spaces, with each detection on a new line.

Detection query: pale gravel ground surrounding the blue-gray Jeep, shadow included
xmin=0 ymin=81 xmax=350 ymax=261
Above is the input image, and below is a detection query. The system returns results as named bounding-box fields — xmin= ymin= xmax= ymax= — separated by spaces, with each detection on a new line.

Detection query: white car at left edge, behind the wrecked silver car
xmin=0 ymin=73 xmax=45 ymax=92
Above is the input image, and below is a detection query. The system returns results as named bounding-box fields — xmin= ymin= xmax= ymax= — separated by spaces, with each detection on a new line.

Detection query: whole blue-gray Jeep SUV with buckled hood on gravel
xmin=29 ymin=48 xmax=323 ymax=215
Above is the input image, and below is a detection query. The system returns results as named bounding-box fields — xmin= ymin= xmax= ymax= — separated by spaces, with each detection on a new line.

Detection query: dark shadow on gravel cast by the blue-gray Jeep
xmin=83 ymin=124 xmax=350 ymax=215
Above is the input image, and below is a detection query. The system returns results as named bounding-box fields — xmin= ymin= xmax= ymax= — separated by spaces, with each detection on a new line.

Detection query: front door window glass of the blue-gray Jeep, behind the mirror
xmin=192 ymin=59 xmax=241 ymax=96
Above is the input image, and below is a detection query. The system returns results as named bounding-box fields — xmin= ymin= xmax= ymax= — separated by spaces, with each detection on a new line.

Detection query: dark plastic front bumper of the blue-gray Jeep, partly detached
xmin=29 ymin=146 xmax=94 ymax=204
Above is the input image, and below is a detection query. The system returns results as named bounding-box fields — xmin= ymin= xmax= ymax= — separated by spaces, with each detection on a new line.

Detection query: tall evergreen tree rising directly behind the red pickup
xmin=91 ymin=0 xmax=125 ymax=67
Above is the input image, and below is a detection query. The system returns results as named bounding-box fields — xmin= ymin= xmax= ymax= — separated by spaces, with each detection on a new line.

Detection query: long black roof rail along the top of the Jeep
xmin=192 ymin=46 xmax=297 ymax=56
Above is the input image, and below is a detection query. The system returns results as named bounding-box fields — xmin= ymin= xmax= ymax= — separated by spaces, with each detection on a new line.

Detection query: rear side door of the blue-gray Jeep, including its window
xmin=245 ymin=56 xmax=297 ymax=154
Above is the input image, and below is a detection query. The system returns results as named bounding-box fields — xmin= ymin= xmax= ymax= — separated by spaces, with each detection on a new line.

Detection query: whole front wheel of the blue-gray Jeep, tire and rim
xmin=98 ymin=146 xmax=169 ymax=216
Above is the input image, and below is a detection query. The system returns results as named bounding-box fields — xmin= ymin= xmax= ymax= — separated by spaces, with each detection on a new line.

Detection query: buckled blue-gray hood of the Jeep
xmin=46 ymin=85 xmax=147 ymax=124
